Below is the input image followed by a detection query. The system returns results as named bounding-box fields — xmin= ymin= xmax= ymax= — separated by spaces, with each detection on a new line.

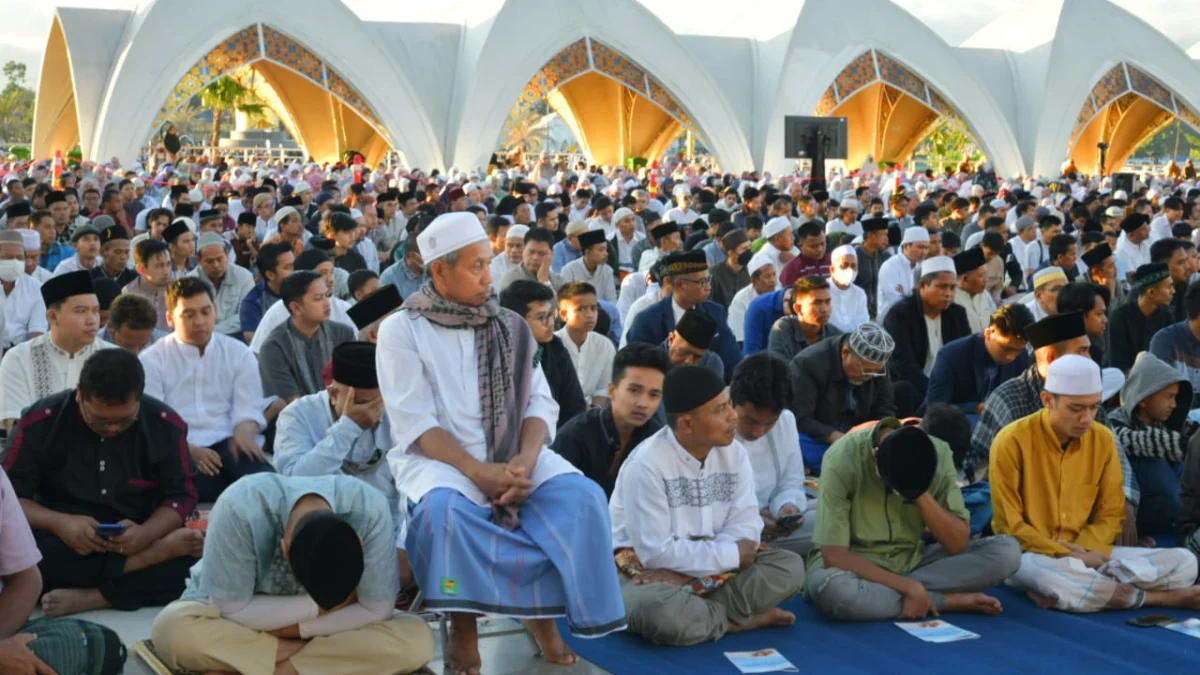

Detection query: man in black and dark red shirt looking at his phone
xmin=4 ymin=350 xmax=204 ymax=616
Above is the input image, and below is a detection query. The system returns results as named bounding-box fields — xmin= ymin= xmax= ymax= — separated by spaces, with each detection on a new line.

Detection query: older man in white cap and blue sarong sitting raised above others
xmin=376 ymin=211 xmax=625 ymax=675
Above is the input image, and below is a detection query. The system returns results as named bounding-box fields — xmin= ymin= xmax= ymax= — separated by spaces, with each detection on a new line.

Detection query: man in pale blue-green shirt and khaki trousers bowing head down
xmin=152 ymin=473 xmax=433 ymax=675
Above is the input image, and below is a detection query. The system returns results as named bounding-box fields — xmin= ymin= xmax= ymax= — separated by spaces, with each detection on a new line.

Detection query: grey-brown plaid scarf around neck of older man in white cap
xmin=404 ymin=282 xmax=536 ymax=530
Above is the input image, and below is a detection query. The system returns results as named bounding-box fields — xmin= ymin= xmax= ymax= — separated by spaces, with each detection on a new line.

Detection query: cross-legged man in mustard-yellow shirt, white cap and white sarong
xmin=988 ymin=354 xmax=1200 ymax=613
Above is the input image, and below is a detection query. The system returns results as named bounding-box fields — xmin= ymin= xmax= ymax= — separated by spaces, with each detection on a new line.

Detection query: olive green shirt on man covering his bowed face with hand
xmin=808 ymin=426 xmax=970 ymax=574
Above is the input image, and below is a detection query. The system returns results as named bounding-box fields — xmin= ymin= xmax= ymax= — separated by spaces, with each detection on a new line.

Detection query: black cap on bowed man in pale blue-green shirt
xmin=288 ymin=509 xmax=362 ymax=611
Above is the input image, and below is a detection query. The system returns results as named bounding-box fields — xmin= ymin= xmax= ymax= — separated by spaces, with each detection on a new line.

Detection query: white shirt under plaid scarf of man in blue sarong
xmin=376 ymin=310 xmax=578 ymax=506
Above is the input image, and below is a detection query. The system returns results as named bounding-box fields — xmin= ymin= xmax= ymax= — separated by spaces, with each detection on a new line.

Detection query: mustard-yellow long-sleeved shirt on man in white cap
xmin=988 ymin=410 xmax=1124 ymax=556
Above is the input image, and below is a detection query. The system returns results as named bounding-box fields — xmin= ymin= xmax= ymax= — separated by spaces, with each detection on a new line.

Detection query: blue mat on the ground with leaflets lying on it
xmin=559 ymin=587 xmax=1200 ymax=675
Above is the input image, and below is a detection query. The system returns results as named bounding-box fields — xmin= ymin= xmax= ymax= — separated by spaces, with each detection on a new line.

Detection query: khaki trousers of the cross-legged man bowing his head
xmin=151 ymin=601 xmax=433 ymax=675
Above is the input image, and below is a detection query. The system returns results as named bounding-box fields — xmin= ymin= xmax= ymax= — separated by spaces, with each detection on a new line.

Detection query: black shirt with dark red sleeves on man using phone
xmin=4 ymin=389 xmax=196 ymax=524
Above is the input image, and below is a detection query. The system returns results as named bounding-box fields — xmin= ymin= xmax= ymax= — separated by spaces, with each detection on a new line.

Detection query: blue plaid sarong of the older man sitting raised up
xmin=406 ymin=473 xmax=625 ymax=638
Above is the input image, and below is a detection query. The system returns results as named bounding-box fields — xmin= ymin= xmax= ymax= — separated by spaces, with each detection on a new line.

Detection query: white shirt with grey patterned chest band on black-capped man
xmin=608 ymin=428 xmax=762 ymax=577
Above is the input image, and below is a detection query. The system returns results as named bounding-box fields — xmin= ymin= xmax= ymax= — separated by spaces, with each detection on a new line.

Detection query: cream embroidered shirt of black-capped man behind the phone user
xmin=0 ymin=333 xmax=115 ymax=419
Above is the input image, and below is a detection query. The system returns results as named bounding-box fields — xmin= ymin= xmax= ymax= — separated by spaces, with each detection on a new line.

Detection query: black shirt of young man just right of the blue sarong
xmin=550 ymin=406 xmax=662 ymax=497
